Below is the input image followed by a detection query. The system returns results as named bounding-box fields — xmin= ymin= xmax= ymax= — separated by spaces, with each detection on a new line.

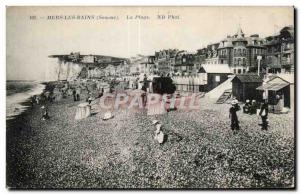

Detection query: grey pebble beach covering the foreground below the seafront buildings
xmin=6 ymin=87 xmax=295 ymax=189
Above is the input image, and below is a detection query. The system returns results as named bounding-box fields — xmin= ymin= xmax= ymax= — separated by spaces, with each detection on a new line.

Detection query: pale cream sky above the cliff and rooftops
xmin=6 ymin=7 xmax=294 ymax=80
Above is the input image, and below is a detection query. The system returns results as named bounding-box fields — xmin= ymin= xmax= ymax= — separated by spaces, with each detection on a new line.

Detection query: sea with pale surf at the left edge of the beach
xmin=6 ymin=80 xmax=45 ymax=120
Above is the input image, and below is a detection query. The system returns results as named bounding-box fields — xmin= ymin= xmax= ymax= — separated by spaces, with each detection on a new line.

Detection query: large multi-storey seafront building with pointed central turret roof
xmin=197 ymin=28 xmax=266 ymax=74
